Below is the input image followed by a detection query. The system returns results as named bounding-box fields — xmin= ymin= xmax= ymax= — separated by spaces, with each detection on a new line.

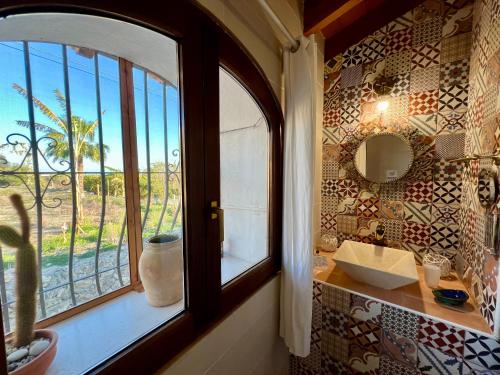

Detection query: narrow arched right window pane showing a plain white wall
xmin=220 ymin=69 xmax=269 ymax=284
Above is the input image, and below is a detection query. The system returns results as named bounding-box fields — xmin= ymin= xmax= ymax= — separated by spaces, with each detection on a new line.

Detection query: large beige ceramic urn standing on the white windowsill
xmin=139 ymin=238 xmax=184 ymax=306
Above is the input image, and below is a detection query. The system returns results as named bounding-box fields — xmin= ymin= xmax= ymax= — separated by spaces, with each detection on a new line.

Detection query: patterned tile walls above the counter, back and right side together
xmin=321 ymin=0 xmax=500 ymax=340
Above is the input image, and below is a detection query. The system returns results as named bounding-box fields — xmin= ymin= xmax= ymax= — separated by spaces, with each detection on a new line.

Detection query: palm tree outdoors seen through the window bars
xmin=12 ymin=83 xmax=109 ymax=230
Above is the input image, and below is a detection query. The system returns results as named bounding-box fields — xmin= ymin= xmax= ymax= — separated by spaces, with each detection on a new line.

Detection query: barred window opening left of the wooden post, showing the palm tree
xmin=0 ymin=42 xmax=130 ymax=332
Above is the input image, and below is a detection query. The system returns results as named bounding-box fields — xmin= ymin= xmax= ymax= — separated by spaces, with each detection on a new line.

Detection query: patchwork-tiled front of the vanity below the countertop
xmin=290 ymin=282 xmax=500 ymax=375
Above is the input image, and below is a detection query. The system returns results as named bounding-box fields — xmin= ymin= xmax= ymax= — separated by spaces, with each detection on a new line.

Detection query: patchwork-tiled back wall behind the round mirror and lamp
xmin=321 ymin=0 xmax=473 ymax=268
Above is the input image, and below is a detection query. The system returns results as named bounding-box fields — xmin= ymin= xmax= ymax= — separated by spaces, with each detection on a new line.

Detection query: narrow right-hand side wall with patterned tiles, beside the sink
xmin=460 ymin=0 xmax=500 ymax=332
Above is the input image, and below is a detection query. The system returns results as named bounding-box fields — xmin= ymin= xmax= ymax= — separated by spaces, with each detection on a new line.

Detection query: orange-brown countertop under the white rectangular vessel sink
xmin=314 ymin=252 xmax=492 ymax=336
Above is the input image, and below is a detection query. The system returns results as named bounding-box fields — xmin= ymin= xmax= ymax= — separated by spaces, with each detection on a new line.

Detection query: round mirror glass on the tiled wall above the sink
xmin=354 ymin=133 xmax=413 ymax=183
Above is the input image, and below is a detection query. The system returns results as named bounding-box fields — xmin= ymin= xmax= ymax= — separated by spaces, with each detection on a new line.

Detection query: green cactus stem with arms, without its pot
xmin=0 ymin=194 xmax=38 ymax=347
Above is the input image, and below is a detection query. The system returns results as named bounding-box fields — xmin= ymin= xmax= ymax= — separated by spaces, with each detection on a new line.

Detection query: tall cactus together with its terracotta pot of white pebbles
xmin=0 ymin=194 xmax=57 ymax=375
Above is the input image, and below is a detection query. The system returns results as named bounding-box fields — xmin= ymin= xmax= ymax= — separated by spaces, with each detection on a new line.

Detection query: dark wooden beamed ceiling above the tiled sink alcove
xmin=304 ymin=0 xmax=423 ymax=60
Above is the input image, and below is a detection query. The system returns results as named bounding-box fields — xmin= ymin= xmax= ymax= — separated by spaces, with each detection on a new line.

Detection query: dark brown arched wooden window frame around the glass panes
xmin=0 ymin=0 xmax=283 ymax=374
